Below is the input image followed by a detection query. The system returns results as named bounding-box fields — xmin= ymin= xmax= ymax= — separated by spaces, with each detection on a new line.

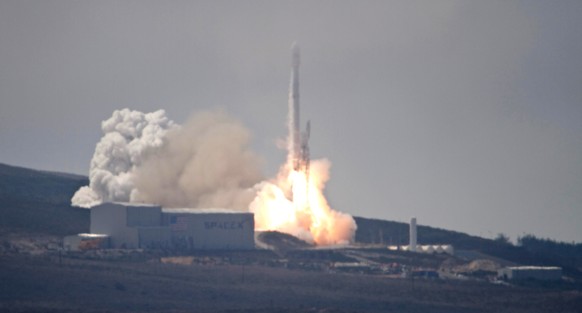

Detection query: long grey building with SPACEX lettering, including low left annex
xmin=64 ymin=203 xmax=255 ymax=250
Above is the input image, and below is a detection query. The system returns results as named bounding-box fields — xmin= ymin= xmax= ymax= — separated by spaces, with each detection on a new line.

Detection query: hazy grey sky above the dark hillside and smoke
xmin=0 ymin=0 xmax=582 ymax=242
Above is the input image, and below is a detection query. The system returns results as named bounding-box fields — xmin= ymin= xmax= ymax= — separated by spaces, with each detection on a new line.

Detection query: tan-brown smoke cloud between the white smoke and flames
xmin=132 ymin=112 xmax=262 ymax=211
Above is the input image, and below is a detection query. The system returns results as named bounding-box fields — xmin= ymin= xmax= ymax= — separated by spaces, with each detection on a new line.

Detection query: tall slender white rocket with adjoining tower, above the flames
xmin=288 ymin=42 xmax=311 ymax=172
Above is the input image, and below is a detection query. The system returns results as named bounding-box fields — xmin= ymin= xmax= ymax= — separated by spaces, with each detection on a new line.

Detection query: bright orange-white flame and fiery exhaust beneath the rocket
xmin=250 ymin=160 xmax=356 ymax=245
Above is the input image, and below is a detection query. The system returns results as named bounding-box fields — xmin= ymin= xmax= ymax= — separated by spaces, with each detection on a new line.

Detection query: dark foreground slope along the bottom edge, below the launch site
xmin=0 ymin=252 xmax=582 ymax=312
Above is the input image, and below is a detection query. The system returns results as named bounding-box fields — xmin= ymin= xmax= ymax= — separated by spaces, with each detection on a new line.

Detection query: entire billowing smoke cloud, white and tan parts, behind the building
xmin=71 ymin=109 xmax=262 ymax=210
